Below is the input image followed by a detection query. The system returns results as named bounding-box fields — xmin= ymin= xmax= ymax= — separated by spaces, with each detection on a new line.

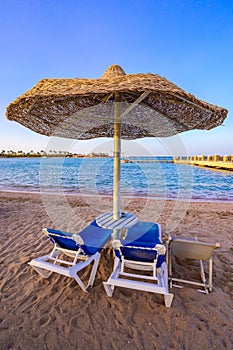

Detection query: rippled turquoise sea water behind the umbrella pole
xmin=0 ymin=157 xmax=233 ymax=201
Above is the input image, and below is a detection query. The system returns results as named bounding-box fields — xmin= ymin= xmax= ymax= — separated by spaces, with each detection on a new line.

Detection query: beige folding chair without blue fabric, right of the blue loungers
xmin=167 ymin=237 xmax=220 ymax=294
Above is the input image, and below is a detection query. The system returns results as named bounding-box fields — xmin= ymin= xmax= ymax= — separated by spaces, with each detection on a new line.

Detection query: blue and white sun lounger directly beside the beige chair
xmin=104 ymin=222 xmax=173 ymax=307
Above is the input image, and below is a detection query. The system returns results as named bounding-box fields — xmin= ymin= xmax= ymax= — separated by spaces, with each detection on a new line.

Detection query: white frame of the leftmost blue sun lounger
xmin=29 ymin=244 xmax=100 ymax=292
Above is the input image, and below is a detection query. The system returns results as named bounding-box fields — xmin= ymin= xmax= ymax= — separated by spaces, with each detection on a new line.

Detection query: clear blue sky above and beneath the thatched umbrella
xmin=0 ymin=0 xmax=233 ymax=154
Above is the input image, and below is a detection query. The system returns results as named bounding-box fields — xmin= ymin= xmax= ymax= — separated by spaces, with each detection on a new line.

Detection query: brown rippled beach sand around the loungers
xmin=0 ymin=192 xmax=233 ymax=350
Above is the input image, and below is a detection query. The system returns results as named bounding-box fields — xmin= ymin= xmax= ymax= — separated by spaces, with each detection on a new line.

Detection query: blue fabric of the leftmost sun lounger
xmin=47 ymin=220 xmax=112 ymax=255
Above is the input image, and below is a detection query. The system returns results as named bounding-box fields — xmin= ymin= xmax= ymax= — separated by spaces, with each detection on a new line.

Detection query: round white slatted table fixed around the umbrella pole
xmin=96 ymin=212 xmax=137 ymax=230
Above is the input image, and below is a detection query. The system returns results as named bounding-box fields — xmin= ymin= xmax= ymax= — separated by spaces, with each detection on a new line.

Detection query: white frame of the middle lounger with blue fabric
xmin=103 ymin=242 xmax=173 ymax=307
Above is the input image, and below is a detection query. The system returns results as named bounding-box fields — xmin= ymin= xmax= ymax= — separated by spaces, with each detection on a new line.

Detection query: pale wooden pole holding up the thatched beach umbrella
xmin=113 ymin=93 xmax=121 ymax=220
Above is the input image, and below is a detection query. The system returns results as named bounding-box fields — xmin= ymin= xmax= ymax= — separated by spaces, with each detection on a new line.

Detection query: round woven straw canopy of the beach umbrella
xmin=6 ymin=65 xmax=227 ymax=139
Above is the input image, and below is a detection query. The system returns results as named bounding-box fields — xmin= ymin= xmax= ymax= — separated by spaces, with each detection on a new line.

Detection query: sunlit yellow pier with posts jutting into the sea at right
xmin=173 ymin=154 xmax=233 ymax=170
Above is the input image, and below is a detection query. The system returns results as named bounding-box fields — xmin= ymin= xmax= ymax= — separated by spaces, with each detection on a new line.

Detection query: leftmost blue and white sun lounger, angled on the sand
xmin=29 ymin=221 xmax=112 ymax=292
